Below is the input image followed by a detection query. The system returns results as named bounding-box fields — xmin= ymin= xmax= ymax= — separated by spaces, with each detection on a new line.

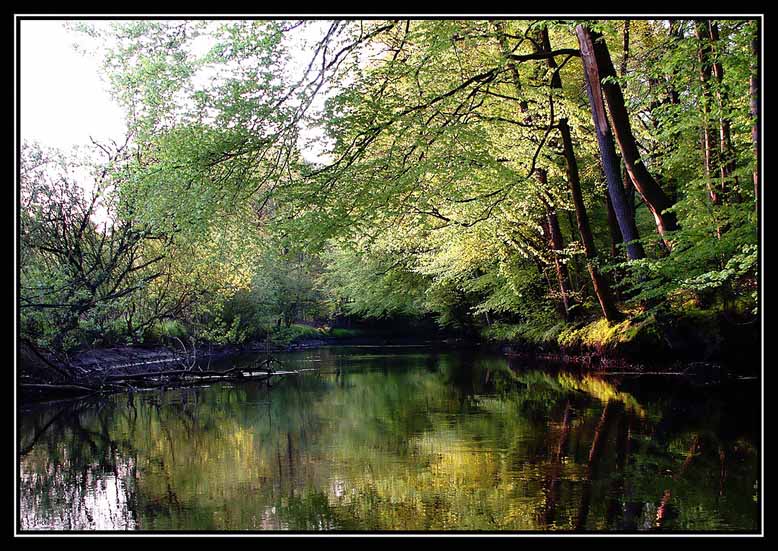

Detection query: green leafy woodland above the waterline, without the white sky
xmin=18 ymin=18 xmax=762 ymax=378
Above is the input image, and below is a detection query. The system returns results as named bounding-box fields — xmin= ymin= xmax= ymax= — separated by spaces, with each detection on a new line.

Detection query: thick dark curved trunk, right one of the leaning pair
xmin=576 ymin=25 xmax=678 ymax=249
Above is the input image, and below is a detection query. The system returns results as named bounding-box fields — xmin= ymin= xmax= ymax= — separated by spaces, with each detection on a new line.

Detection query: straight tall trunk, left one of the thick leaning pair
xmin=577 ymin=25 xmax=645 ymax=260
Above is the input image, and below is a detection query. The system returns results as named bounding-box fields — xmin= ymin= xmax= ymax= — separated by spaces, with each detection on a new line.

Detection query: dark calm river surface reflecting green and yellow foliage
xmin=19 ymin=347 xmax=761 ymax=531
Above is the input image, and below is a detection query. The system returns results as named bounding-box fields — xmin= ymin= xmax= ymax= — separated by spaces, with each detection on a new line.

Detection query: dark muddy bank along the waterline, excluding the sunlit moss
xmin=19 ymin=316 xmax=761 ymax=399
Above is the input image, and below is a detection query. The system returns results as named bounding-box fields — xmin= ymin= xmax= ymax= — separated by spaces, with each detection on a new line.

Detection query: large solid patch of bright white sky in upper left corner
xmin=19 ymin=20 xmax=126 ymax=150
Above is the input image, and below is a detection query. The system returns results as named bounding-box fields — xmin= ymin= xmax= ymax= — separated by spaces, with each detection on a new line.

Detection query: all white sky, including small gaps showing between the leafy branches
xmin=18 ymin=20 xmax=340 ymax=223
